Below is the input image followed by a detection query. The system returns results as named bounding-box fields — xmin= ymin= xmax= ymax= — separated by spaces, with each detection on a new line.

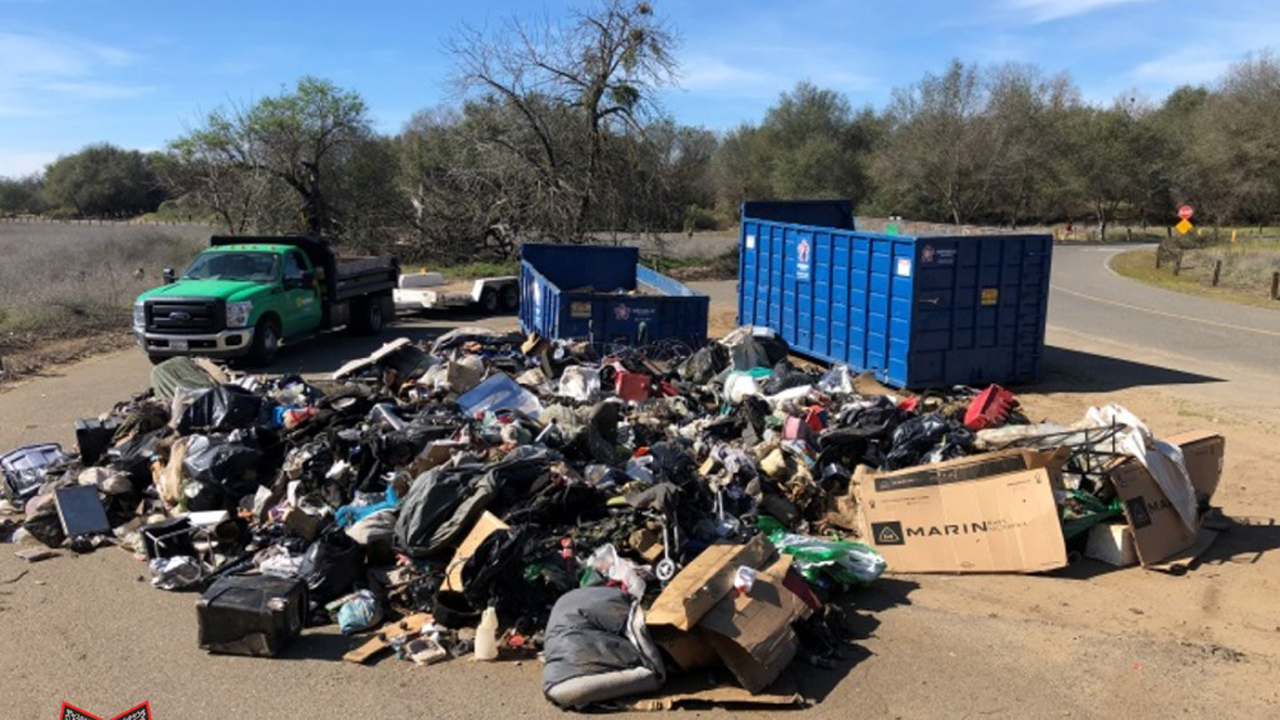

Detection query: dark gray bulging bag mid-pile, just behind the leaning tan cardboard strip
xmin=396 ymin=464 xmax=497 ymax=557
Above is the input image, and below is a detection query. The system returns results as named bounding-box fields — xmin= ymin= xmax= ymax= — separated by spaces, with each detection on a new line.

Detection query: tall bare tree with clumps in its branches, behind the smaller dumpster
xmin=445 ymin=0 xmax=677 ymax=238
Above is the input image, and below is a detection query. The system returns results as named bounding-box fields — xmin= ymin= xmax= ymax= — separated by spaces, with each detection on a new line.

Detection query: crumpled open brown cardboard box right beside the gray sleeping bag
xmin=646 ymin=536 xmax=809 ymax=694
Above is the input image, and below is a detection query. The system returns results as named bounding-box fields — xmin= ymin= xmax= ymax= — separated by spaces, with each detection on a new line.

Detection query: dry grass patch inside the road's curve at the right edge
xmin=1111 ymin=246 xmax=1280 ymax=310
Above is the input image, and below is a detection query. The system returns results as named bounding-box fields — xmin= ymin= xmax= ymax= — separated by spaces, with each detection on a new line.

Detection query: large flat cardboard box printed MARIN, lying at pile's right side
xmin=851 ymin=450 xmax=1066 ymax=573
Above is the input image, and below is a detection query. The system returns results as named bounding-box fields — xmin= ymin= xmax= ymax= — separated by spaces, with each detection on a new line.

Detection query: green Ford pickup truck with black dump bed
xmin=133 ymin=237 xmax=399 ymax=364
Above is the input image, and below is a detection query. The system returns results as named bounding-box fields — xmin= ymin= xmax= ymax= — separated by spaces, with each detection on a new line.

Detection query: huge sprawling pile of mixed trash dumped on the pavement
xmin=0 ymin=328 xmax=1221 ymax=707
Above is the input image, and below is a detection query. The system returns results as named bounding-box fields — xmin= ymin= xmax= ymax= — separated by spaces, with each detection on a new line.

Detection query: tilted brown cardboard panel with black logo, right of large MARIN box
xmin=1111 ymin=459 xmax=1199 ymax=566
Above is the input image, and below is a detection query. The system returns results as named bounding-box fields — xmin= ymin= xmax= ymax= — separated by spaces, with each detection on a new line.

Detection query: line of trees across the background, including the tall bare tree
xmin=0 ymin=0 xmax=1280 ymax=254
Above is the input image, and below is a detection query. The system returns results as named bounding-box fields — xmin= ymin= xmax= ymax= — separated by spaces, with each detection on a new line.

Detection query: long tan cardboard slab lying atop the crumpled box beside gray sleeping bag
xmin=645 ymin=536 xmax=778 ymax=630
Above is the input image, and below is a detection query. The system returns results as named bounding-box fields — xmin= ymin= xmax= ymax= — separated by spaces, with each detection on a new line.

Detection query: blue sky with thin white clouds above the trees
xmin=0 ymin=0 xmax=1280 ymax=176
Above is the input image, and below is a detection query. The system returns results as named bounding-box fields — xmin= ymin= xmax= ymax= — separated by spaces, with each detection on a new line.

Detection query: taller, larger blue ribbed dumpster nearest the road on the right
xmin=737 ymin=202 xmax=1053 ymax=388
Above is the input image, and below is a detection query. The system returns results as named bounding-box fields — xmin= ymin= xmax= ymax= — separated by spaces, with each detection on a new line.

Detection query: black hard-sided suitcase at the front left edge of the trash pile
xmin=196 ymin=575 xmax=307 ymax=657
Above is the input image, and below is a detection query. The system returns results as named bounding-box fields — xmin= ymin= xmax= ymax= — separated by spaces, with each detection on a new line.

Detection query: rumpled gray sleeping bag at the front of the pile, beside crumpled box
xmin=543 ymin=587 xmax=666 ymax=707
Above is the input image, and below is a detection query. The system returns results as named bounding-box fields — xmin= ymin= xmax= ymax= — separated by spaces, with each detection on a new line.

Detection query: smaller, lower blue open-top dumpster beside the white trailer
xmin=520 ymin=243 xmax=709 ymax=347
